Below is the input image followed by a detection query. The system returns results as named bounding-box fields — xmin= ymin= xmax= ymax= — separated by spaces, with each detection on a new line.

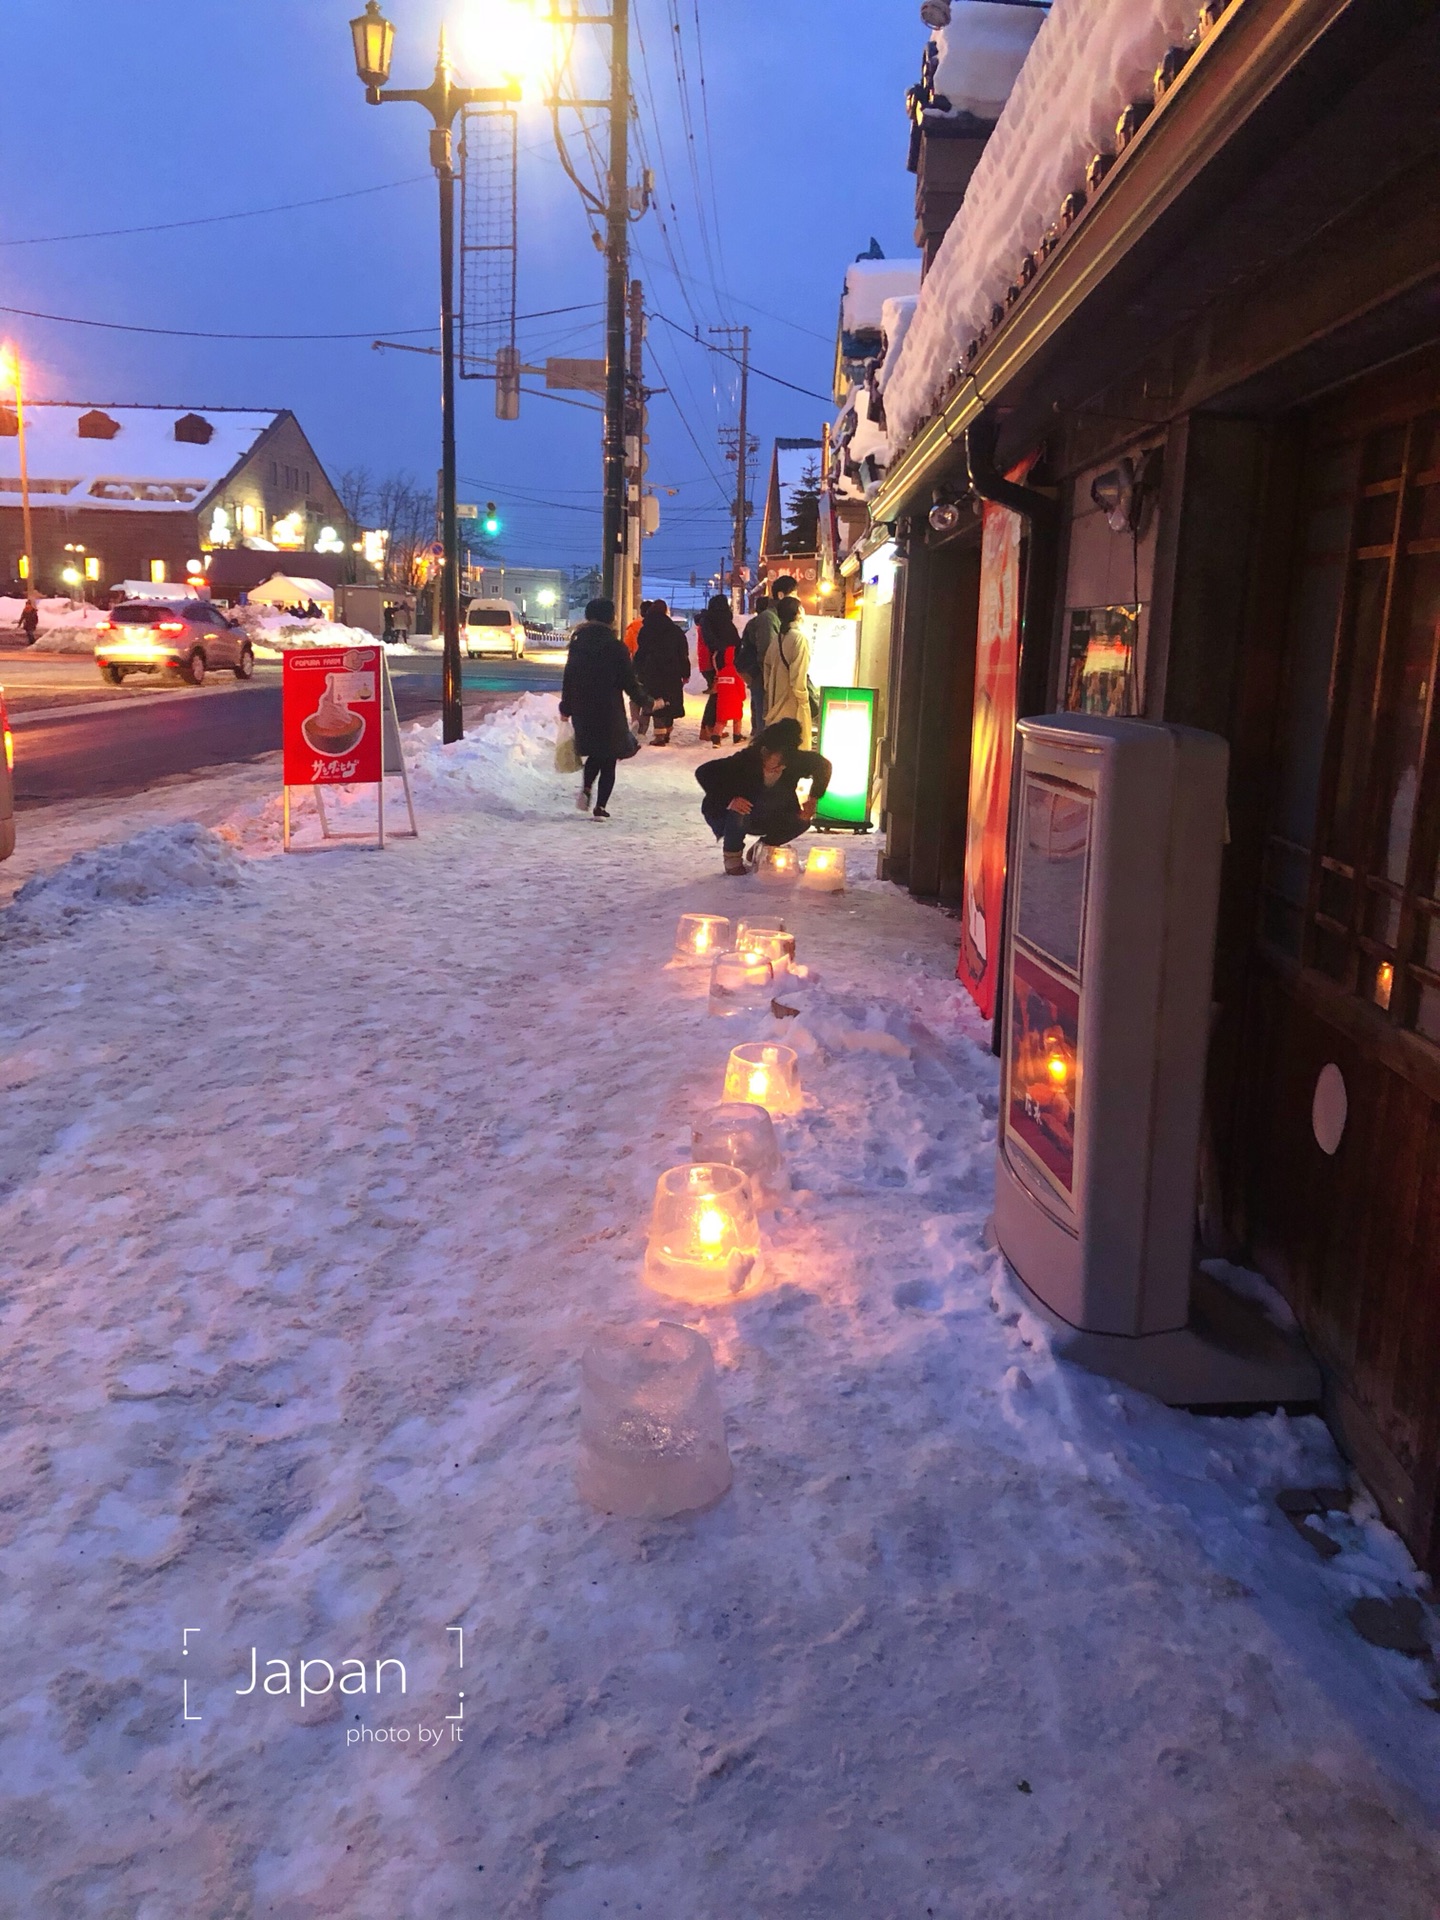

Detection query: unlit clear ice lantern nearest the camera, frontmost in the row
xmin=576 ymin=1321 xmax=732 ymax=1521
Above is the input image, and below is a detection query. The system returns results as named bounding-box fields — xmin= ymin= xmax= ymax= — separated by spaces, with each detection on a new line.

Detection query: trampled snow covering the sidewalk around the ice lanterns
xmin=0 ymin=695 xmax=1440 ymax=1920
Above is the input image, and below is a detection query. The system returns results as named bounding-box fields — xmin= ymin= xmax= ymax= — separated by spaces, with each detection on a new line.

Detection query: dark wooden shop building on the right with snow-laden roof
xmin=868 ymin=0 xmax=1440 ymax=1574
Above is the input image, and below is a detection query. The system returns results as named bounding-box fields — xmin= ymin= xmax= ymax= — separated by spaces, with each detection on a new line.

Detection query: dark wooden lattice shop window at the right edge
xmin=1261 ymin=413 xmax=1440 ymax=1043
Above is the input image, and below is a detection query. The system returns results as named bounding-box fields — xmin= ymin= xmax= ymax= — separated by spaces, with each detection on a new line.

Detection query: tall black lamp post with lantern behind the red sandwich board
xmin=349 ymin=0 xmax=520 ymax=743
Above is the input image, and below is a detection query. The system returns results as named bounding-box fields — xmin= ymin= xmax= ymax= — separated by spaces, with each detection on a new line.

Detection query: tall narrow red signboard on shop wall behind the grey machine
xmin=956 ymin=487 xmax=1027 ymax=1020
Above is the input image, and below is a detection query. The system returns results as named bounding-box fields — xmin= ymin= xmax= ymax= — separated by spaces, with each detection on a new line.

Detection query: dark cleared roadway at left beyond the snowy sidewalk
xmin=0 ymin=651 xmax=564 ymax=808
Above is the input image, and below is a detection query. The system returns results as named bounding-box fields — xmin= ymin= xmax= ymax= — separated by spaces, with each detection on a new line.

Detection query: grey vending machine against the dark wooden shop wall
xmin=995 ymin=714 xmax=1319 ymax=1405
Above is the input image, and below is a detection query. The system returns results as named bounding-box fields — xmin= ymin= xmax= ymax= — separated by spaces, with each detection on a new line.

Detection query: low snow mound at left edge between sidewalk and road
xmin=0 ymin=820 xmax=242 ymax=937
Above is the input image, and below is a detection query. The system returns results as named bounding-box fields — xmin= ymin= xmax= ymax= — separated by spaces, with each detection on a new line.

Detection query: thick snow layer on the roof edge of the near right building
xmin=885 ymin=0 xmax=1196 ymax=447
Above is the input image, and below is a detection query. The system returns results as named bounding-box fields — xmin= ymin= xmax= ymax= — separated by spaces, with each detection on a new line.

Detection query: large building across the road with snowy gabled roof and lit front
xmin=0 ymin=399 xmax=349 ymax=591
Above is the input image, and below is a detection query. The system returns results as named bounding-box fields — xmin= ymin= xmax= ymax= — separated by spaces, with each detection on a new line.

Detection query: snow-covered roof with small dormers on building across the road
xmin=0 ymin=399 xmax=280 ymax=513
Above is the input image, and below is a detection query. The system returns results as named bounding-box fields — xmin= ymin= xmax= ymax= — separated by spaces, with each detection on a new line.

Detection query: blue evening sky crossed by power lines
xmin=0 ymin=0 xmax=925 ymax=578
